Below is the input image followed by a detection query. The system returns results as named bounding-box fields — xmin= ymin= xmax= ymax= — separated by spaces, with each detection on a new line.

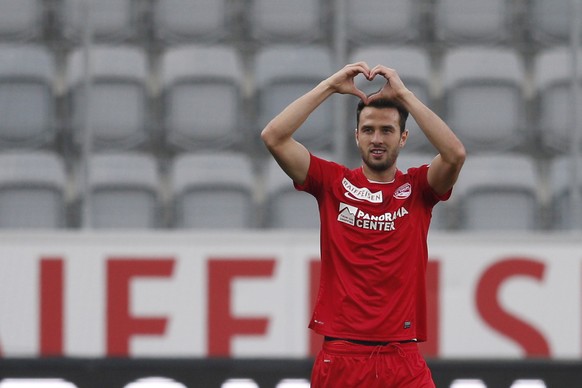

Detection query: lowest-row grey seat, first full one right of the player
xmin=455 ymin=153 xmax=541 ymax=231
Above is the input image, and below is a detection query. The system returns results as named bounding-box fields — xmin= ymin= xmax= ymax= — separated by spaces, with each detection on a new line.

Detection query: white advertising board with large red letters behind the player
xmin=0 ymin=232 xmax=582 ymax=359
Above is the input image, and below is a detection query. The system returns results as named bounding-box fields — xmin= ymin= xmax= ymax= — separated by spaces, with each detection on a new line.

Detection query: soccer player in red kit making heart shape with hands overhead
xmin=261 ymin=62 xmax=465 ymax=388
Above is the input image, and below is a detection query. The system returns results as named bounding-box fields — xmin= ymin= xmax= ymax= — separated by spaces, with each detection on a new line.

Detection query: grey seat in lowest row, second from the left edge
xmin=82 ymin=152 xmax=162 ymax=229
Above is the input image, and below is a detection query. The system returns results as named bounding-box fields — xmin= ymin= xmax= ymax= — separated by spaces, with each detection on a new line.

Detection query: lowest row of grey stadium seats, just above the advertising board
xmin=0 ymin=151 xmax=582 ymax=231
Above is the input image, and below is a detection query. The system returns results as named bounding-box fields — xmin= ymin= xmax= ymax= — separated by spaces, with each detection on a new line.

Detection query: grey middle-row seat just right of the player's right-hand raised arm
xmin=443 ymin=46 xmax=528 ymax=151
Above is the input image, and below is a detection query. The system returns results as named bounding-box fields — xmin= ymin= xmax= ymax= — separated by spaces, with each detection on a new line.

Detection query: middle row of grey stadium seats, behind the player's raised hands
xmin=0 ymin=44 xmax=582 ymax=156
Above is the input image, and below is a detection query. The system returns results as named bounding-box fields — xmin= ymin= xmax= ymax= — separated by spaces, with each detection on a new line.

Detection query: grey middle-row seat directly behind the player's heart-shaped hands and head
xmin=350 ymin=45 xmax=433 ymax=151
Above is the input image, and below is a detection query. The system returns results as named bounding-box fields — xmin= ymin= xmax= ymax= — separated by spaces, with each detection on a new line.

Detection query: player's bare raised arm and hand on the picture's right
xmin=369 ymin=65 xmax=466 ymax=194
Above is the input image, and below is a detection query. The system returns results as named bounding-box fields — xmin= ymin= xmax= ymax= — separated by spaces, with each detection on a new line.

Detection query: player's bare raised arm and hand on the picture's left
xmin=261 ymin=62 xmax=370 ymax=184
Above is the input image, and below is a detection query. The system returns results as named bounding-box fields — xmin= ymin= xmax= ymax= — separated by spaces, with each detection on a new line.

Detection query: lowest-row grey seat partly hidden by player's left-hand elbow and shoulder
xmin=263 ymin=159 xmax=319 ymax=230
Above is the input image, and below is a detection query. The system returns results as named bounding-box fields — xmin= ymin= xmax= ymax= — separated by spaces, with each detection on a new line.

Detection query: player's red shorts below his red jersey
xmin=311 ymin=340 xmax=435 ymax=388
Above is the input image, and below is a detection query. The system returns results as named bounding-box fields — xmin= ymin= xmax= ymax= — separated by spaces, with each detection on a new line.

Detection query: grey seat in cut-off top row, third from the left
xmin=152 ymin=0 xmax=233 ymax=44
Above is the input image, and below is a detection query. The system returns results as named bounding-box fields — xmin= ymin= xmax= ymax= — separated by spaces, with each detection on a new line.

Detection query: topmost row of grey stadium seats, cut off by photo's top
xmin=0 ymin=0 xmax=571 ymax=45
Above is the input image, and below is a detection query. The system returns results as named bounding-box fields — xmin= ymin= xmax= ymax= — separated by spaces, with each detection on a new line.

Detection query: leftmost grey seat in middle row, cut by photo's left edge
xmin=0 ymin=44 xmax=56 ymax=148
